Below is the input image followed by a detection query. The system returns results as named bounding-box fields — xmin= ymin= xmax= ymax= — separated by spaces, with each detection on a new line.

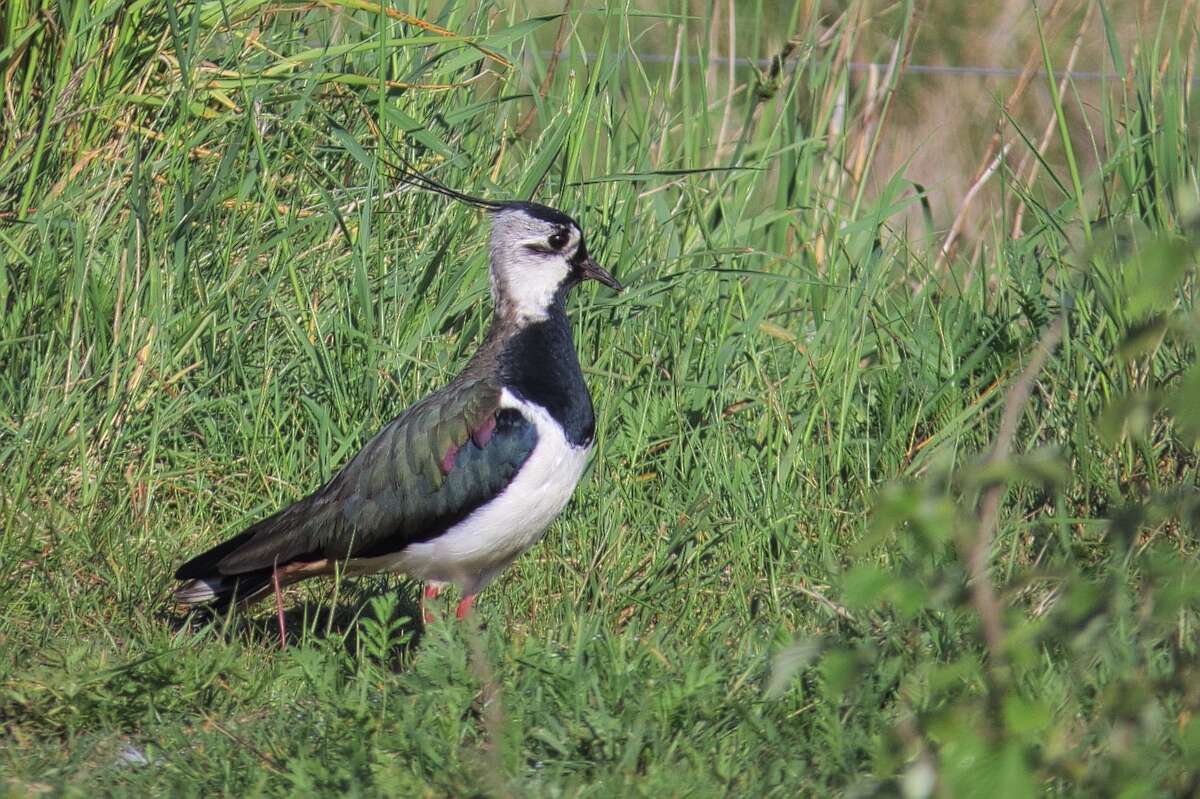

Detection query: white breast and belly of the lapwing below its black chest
xmin=386 ymin=389 xmax=592 ymax=594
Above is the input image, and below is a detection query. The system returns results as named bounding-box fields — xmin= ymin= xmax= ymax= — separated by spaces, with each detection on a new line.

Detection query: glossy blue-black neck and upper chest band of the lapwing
xmin=490 ymin=287 xmax=595 ymax=446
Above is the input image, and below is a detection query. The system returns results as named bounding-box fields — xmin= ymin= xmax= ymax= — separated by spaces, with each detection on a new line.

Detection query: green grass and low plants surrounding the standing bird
xmin=0 ymin=0 xmax=1200 ymax=797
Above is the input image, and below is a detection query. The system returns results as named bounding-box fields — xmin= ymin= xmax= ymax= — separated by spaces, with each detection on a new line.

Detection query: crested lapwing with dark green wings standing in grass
xmin=173 ymin=173 xmax=624 ymax=648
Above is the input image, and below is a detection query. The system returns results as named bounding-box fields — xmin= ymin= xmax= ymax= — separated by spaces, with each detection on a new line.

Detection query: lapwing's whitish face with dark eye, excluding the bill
xmin=491 ymin=209 xmax=582 ymax=320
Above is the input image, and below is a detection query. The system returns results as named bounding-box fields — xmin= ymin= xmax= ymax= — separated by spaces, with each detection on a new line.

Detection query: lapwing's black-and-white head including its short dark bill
xmin=491 ymin=203 xmax=622 ymax=320
